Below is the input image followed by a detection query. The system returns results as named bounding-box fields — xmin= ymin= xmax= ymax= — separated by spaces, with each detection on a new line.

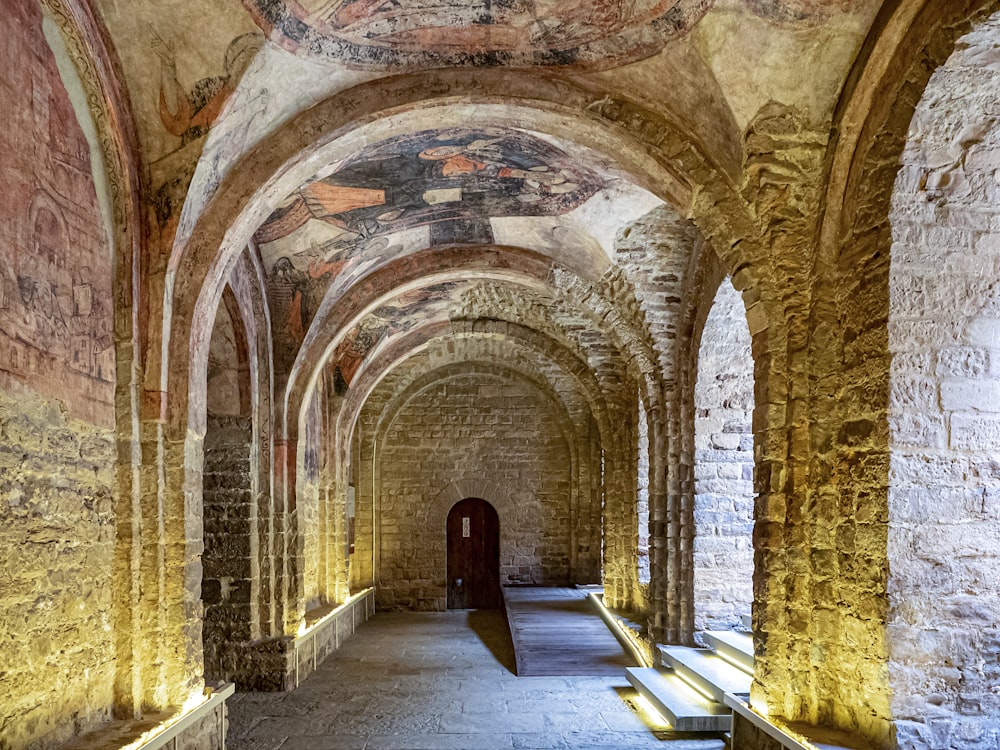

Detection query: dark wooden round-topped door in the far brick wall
xmin=447 ymin=497 xmax=500 ymax=609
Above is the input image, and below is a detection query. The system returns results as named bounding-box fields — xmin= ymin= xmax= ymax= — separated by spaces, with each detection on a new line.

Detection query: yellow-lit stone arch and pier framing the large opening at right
xmin=788 ymin=0 xmax=1000 ymax=746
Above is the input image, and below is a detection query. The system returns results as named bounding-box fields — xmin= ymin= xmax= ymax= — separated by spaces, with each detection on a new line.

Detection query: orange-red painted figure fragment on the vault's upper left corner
xmin=151 ymin=32 xmax=264 ymax=146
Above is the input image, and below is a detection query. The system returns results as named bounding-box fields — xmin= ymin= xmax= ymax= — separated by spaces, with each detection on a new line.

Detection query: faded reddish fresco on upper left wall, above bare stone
xmin=0 ymin=1 xmax=115 ymax=424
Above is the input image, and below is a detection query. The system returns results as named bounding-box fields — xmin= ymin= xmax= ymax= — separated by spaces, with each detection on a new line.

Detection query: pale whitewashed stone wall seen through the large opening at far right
xmin=888 ymin=10 xmax=1000 ymax=748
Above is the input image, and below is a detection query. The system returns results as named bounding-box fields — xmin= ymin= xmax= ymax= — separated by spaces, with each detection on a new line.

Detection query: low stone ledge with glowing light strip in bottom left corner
xmin=62 ymin=684 xmax=236 ymax=750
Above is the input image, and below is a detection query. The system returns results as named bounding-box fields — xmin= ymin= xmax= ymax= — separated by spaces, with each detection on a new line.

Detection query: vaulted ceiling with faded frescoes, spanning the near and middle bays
xmin=86 ymin=0 xmax=880 ymax=424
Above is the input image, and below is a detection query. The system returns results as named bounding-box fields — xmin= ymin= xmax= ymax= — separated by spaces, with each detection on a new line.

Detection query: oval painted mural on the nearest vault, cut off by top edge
xmin=244 ymin=0 xmax=711 ymax=69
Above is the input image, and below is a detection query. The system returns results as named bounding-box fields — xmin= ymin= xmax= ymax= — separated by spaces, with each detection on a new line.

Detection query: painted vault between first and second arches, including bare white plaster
xmin=254 ymin=128 xmax=661 ymax=368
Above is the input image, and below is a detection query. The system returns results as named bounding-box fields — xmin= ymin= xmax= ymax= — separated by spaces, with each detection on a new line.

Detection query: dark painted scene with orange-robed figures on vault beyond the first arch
xmin=256 ymin=129 xmax=603 ymax=243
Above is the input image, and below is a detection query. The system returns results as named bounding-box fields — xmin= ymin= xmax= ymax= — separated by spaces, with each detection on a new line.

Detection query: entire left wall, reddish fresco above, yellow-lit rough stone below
xmin=0 ymin=0 xmax=117 ymax=750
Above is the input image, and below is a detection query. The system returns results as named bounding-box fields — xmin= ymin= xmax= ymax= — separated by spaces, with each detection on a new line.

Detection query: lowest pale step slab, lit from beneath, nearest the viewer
xmin=625 ymin=667 xmax=733 ymax=732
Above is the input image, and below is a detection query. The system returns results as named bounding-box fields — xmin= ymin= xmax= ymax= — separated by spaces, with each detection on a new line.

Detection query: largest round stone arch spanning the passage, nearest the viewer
xmin=154 ymin=71 xmax=780 ymax=680
